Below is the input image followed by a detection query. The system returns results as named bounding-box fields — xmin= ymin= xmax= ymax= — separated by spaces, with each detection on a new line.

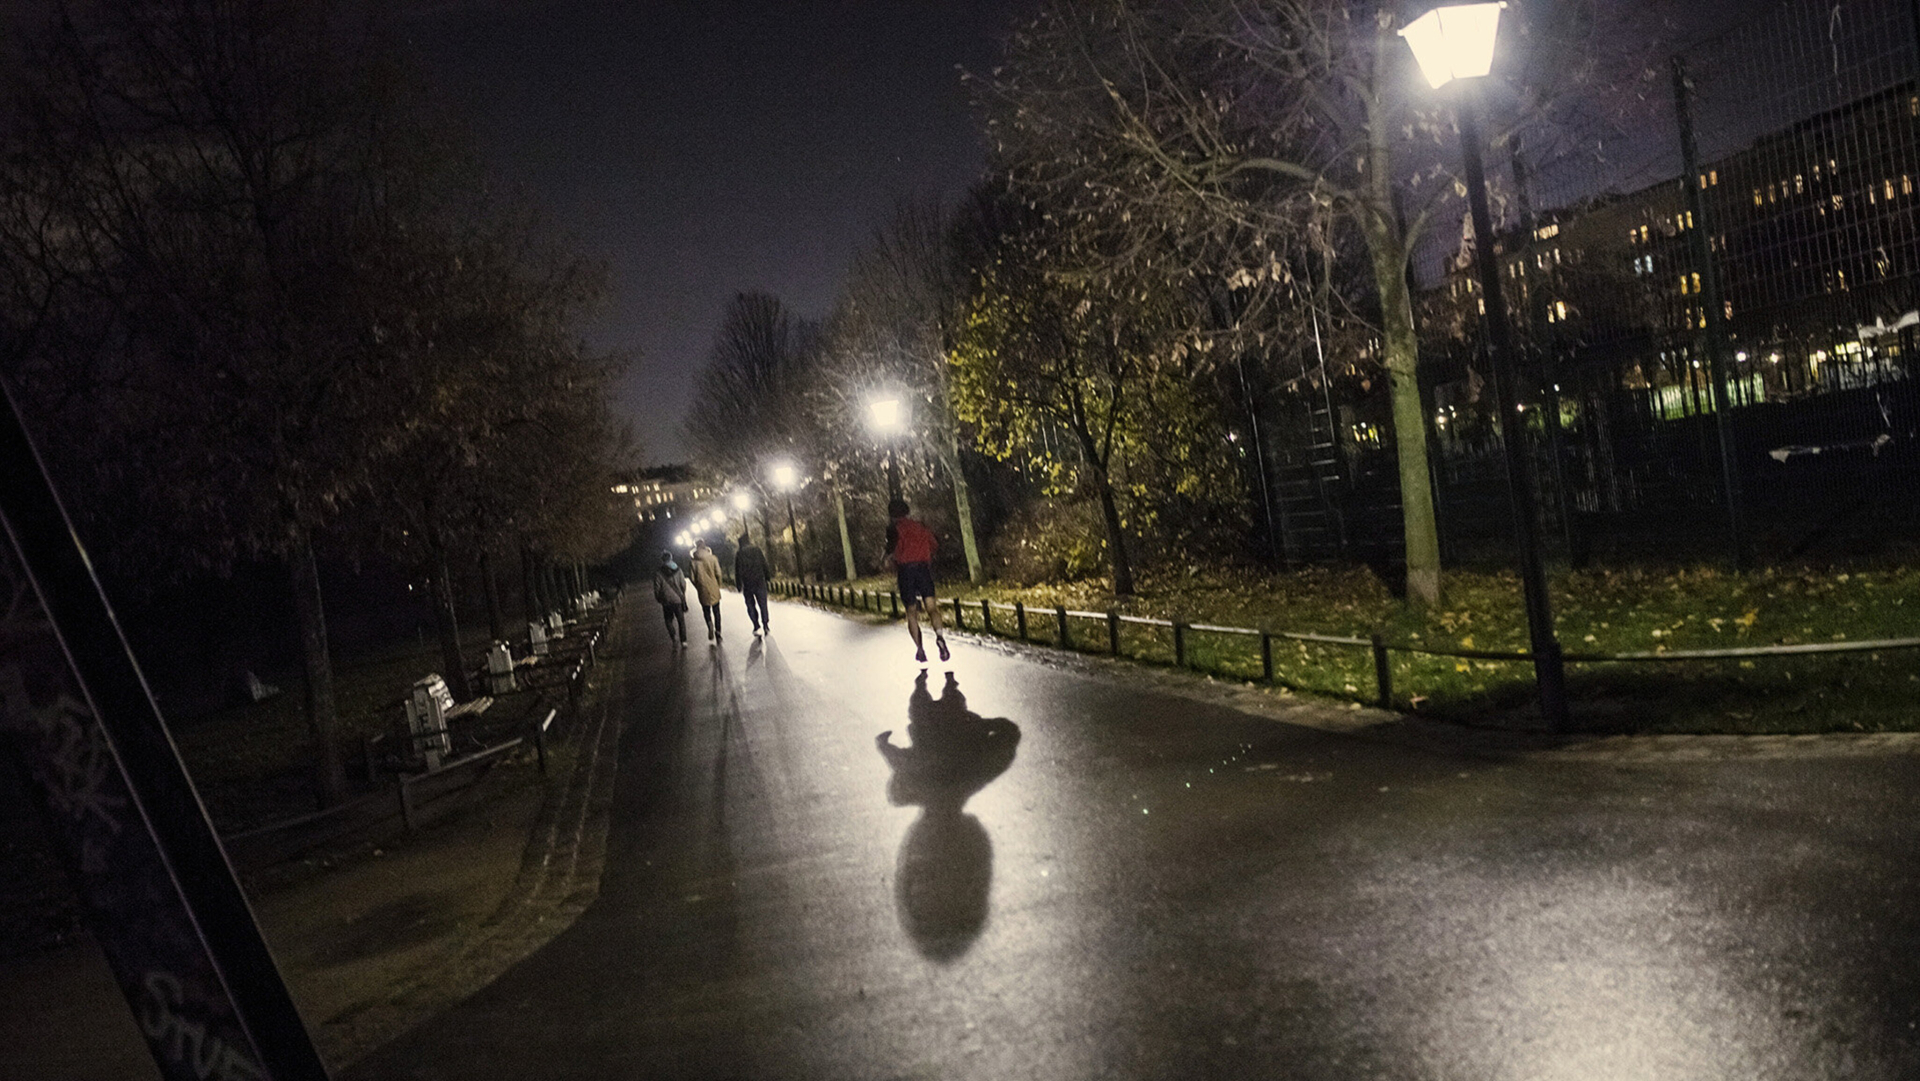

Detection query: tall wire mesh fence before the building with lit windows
xmin=1269 ymin=0 xmax=1920 ymax=563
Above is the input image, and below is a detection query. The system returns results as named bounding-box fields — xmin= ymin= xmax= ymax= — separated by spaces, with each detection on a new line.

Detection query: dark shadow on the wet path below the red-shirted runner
xmin=876 ymin=672 xmax=1020 ymax=962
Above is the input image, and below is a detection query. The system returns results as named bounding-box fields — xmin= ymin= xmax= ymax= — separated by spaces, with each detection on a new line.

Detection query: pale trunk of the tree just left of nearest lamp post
xmin=1365 ymin=217 xmax=1440 ymax=609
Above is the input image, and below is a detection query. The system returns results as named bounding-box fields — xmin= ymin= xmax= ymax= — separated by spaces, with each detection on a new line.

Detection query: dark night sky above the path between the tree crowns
xmin=405 ymin=0 xmax=1029 ymax=461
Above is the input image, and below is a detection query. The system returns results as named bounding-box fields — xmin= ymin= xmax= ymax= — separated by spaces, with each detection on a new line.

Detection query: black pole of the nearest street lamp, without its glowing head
xmin=1459 ymin=81 xmax=1567 ymax=732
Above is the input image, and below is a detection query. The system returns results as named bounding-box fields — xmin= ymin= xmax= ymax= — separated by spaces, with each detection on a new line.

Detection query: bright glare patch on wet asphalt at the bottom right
xmin=1297 ymin=870 xmax=1799 ymax=1081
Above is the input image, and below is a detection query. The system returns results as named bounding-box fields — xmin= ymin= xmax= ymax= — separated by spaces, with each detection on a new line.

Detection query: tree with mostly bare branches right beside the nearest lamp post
xmin=981 ymin=0 xmax=1651 ymax=605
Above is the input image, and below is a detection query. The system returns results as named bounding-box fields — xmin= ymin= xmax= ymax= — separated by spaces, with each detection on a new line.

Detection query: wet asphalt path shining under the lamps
xmin=353 ymin=595 xmax=1920 ymax=1081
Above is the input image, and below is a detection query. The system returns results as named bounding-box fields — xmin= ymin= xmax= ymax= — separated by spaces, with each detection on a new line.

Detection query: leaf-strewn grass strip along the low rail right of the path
xmin=798 ymin=568 xmax=1920 ymax=733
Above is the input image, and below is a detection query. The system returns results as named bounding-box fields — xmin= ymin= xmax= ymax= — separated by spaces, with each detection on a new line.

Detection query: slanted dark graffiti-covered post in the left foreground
xmin=0 ymin=384 xmax=326 ymax=1081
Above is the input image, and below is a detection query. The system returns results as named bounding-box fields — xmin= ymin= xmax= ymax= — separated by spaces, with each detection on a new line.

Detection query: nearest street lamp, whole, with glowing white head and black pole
xmin=1400 ymin=4 xmax=1567 ymax=730
